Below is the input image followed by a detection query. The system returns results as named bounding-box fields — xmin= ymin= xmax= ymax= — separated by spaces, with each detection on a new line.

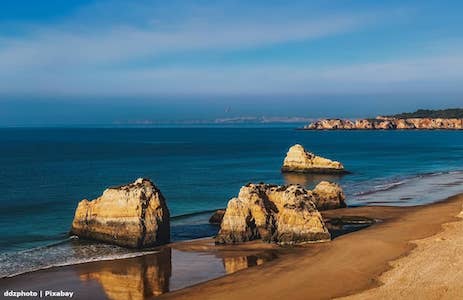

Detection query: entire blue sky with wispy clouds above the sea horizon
xmin=0 ymin=0 xmax=463 ymax=126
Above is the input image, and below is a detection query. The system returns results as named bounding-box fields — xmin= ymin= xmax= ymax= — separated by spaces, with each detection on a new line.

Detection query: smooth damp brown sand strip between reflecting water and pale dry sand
xmin=161 ymin=194 xmax=463 ymax=299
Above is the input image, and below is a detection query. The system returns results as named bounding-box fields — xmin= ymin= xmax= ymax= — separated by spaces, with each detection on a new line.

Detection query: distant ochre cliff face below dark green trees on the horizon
xmin=304 ymin=117 xmax=463 ymax=130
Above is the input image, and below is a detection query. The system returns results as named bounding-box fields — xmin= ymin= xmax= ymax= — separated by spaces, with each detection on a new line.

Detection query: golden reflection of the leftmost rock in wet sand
xmin=80 ymin=247 xmax=172 ymax=300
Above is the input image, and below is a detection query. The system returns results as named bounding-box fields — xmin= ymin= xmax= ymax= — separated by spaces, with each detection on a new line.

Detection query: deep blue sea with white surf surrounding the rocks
xmin=0 ymin=126 xmax=463 ymax=277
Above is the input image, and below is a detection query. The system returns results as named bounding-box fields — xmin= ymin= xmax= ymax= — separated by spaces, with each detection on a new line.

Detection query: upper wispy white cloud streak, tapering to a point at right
xmin=0 ymin=16 xmax=365 ymax=71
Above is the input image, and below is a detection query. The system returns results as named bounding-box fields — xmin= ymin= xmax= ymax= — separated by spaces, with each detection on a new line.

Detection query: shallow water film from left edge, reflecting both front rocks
xmin=0 ymin=247 xmax=278 ymax=300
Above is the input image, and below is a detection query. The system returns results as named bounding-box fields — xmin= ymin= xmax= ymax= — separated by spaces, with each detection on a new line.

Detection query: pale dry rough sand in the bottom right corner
xmin=343 ymin=198 xmax=463 ymax=299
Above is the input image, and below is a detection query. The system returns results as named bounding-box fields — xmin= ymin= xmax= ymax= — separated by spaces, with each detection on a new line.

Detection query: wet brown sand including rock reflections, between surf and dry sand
xmin=0 ymin=195 xmax=463 ymax=299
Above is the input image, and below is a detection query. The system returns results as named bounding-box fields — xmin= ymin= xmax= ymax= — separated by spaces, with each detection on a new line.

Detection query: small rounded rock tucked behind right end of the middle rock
xmin=312 ymin=181 xmax=346 ymax=210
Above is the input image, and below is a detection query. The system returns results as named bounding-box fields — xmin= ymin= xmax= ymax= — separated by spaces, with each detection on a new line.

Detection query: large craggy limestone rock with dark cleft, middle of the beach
xmin=215 ymin=184 xmax=330 ymax=244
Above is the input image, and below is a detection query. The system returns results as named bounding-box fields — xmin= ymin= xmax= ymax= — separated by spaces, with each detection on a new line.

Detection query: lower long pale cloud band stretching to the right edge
xmin=0 ymin=56 xmax=463 ymax=96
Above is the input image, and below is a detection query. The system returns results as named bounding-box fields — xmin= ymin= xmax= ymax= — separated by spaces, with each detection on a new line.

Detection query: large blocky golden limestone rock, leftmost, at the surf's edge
xmin=71 ymin=178 xmax=170 ymax=248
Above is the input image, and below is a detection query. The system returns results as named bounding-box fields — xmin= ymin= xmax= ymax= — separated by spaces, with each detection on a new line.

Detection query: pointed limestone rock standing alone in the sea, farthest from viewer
xmin=281 ymin=144 xmax=346 ymax=173
